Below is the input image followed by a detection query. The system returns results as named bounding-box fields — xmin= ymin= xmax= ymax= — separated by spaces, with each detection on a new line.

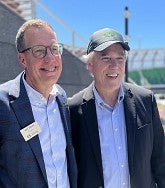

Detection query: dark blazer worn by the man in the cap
xmin=68 ymin=84 xmax=165 ymax=188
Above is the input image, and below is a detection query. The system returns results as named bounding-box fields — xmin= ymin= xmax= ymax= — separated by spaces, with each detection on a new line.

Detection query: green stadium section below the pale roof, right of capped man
xmin=129 ymin=68 xmax=165 ymax=85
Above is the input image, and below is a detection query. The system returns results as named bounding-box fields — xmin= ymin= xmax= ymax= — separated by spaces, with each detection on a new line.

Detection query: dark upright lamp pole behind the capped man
xmin=124 ymin=7 xmax=129 ymax=82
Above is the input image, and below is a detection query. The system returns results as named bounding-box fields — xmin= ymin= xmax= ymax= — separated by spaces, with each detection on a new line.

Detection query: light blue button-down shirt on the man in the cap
xmin=93 ymin=85 xmax=130 ymax=188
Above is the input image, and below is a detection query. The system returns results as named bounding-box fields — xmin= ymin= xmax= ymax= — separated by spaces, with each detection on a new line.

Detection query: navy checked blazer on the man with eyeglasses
xmin=0 ymin=72 xmax=77 ymax=188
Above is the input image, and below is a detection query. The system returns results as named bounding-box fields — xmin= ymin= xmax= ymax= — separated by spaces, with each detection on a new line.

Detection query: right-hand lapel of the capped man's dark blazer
xmin=124 ymin=84 xmax=136 ymax=174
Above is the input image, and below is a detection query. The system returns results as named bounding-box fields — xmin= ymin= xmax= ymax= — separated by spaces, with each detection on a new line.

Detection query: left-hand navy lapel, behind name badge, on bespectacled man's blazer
xmin=10 ymin=75 xmax=47 ymax=181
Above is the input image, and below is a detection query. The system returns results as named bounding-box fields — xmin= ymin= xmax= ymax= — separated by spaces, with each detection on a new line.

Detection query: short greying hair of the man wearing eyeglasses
xmin=15 ymin=19 xmax=53 ymax=52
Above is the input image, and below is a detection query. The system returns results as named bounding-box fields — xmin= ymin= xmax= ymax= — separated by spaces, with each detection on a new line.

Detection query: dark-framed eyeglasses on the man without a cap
xmin=20 ymin=43 xmax=63 ymax=59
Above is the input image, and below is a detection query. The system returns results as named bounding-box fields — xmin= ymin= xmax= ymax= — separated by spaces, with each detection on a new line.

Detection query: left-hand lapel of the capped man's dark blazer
xmin=82 ymin=85 xmax=103 ymax=177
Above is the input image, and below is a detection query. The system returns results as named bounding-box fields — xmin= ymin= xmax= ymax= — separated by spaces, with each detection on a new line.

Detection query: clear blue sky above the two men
xmin=36 ymin=0 xmax=165 ymax=49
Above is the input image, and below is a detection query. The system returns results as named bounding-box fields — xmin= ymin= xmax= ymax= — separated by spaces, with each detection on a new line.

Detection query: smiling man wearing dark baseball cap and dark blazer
xmin=68 ymin=28 xmax=165 ymax=188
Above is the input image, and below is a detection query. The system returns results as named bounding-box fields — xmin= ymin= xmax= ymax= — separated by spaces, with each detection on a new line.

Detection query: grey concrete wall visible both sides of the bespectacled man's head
xmin=0 ymin=2 xmax=92 ymax=96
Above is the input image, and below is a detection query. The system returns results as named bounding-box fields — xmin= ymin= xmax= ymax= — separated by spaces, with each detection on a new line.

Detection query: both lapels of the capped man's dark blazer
xmin=82 ymin=85 xmax=136 ymax=178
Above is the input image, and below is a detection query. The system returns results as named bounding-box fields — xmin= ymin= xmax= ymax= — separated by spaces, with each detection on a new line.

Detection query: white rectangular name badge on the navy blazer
xmin=20 ymin=122 xmax=41 ymax=141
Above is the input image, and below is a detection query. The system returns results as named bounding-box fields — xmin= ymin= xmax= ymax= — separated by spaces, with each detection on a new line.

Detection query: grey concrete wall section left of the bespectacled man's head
xmin=0 ymin=3 xmax=24 ymax=83
